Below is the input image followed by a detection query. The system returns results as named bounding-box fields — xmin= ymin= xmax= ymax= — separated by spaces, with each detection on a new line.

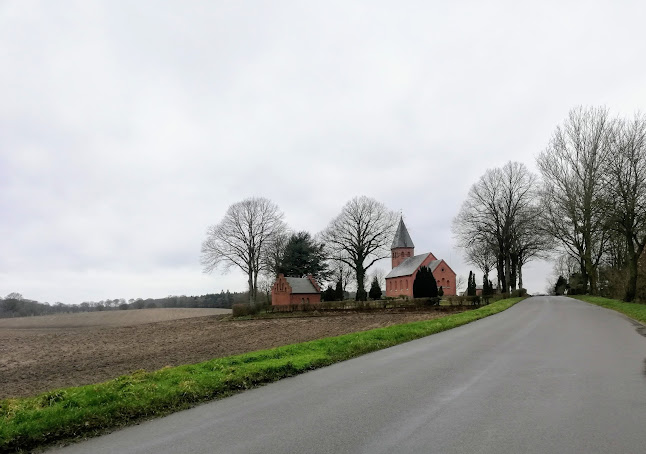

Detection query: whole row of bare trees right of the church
xmin=453 ymin=107 xmax=646 ymax=301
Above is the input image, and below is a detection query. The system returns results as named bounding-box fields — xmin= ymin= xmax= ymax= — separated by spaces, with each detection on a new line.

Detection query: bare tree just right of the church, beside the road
xmin=453 ymin=162 xmax=539 ymax=292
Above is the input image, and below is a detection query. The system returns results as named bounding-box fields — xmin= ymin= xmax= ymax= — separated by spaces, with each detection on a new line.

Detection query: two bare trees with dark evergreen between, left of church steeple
xmin=201 ymin=196 xmax=397 ymax=303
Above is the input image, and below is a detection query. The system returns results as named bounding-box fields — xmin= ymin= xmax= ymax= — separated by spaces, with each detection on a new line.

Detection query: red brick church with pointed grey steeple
xmin=386 ymin=218 xmax=456 ymax=298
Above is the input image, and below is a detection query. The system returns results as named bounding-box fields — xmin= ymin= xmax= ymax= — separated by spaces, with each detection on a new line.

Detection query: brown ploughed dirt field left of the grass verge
xmin=0 ymin=309 xmax=466 ymax=399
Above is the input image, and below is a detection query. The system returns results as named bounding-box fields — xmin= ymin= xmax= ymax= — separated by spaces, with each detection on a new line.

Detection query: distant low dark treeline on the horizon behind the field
xmin=0 ymin=290 xmax=249 ymax=318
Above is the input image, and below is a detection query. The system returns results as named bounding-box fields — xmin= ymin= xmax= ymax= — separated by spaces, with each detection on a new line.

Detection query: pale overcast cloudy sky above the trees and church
xmin=0 ymin=0 xmax=646 ymax=304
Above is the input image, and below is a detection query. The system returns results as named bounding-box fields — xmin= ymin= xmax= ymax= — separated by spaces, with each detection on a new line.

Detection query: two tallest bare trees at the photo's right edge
xmin=538 ymin=108 xmax=646 ymax=301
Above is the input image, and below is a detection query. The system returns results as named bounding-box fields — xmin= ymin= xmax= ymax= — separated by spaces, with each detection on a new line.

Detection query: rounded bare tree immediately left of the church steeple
xmin=321 ymin=196 xmax=397 ymax=300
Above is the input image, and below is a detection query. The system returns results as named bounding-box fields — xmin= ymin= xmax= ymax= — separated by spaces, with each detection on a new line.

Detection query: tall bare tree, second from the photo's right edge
xmin=538 ymin=108 xmax=615 ymax=294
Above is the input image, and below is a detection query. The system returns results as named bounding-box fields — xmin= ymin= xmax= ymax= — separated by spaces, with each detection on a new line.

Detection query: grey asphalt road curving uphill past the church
xmin=53 ymin=297 xmax=646 ymax=454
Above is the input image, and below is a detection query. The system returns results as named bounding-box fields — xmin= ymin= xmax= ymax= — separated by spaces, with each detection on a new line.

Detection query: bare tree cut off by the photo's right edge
xmin=603 ymin=114 xmax=646 ymax=301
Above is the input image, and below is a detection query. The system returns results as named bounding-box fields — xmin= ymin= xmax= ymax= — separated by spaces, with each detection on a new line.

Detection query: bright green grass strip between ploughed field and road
xmin=0 ymin=298 xmax=522 ymax=452
